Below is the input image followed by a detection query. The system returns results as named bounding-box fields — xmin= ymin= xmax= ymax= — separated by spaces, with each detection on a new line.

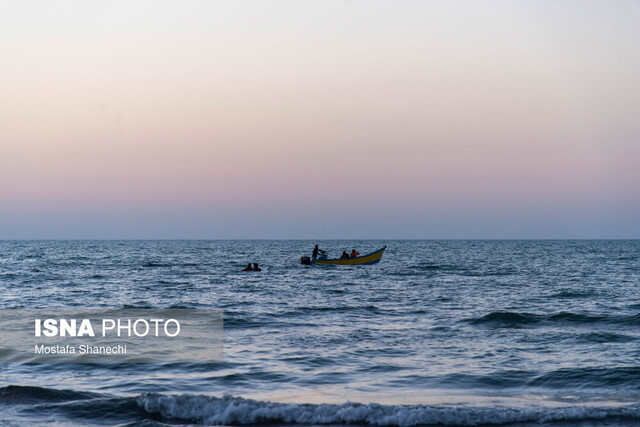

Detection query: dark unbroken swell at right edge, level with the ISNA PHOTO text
xmin=463 ymin=311 xmax=640 ymax=327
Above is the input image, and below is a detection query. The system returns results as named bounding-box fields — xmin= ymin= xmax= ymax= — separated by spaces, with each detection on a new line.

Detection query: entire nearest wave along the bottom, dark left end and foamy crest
xmin=5 ymin=386 xmax=640 ymax=427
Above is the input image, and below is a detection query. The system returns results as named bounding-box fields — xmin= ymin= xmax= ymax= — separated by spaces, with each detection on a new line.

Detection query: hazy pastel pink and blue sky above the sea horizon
xmin=0 ymin=0 xmax=640 ymax=239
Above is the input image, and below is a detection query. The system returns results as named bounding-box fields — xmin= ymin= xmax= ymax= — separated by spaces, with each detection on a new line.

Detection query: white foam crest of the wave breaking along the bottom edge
xmin=138 ymin=394 xmax=640 ymax=426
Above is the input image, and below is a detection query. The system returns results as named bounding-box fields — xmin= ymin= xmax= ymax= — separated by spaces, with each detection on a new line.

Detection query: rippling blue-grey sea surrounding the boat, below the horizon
xmin=0 ymin=240 xmax=640 ymax=426
